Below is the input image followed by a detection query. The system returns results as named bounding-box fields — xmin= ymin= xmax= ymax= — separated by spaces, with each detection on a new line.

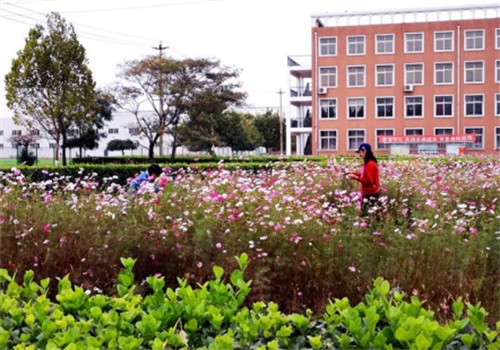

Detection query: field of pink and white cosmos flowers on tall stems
xmin=0 ymin=158 xmax=500 ymax=323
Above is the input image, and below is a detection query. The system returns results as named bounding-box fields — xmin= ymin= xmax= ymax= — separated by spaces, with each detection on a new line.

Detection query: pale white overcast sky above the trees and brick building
xmin=0 ymin=0 xmax=492 ymax=118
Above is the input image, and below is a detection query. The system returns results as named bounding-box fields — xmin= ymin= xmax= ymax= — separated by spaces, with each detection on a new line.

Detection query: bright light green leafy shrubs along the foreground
xmin=0 ymin=254 xmax=500 ymax=350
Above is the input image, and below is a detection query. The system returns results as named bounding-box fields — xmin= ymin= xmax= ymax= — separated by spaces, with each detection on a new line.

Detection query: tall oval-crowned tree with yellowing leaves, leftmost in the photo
xmin=5 ymin=12 xmax=96 ymax=165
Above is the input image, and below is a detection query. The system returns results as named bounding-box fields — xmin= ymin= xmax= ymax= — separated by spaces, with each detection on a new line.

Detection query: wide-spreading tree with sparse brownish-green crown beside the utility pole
xmin=114 ymin=56 xmax=245 ymax=160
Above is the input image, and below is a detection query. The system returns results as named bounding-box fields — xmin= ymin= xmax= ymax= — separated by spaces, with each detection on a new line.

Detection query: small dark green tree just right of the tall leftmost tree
xmin=66 ymin=90 xmax=115 ymax=157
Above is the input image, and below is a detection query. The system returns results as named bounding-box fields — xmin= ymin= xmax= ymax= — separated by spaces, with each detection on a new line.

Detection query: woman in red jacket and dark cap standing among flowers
xmin=347 ymin=143 xmax=380 ymax=216
